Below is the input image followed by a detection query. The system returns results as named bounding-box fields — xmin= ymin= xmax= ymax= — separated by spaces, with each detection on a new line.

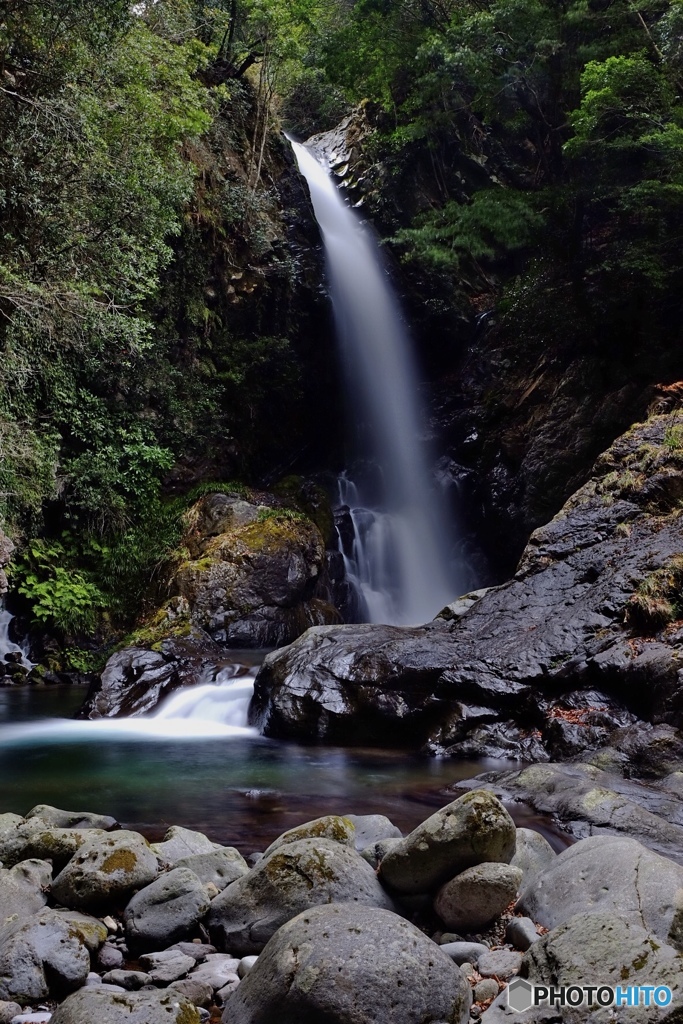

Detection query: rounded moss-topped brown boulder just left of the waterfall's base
xmin=169 ymin=494 xmax=340 ymax=647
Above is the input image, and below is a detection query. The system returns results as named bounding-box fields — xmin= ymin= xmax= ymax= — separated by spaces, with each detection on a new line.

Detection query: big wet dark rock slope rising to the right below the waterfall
xmin=252 ymin=413 xmax=683 ymax=760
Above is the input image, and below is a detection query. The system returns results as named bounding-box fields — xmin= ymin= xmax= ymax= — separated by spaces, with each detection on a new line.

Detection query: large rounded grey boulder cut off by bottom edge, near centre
xmin=222 ymin=903 xmax=471 ymax=1024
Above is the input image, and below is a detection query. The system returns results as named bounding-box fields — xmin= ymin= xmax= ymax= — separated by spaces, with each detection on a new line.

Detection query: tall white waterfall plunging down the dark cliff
xmin=292 ymin=142 xmax=459 ymax=625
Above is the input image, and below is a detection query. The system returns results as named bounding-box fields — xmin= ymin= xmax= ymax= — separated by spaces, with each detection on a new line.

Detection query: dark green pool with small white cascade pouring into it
xmin=0 ymin=659 xmax=568 ymax=854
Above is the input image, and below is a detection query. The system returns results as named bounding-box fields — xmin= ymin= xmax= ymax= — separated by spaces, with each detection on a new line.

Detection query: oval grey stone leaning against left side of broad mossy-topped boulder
xmin=123 ymin=867 xmax=209 ymax=952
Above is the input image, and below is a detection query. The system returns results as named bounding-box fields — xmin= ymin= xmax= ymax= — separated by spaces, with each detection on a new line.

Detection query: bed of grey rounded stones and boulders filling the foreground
xmin=0 ymin=788 xmax=683 ymax=1024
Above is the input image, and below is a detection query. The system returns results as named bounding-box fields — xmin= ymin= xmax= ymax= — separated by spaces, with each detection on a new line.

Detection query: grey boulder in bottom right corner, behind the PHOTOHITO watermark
xmin=481 ymin=913 xmax=683 ymax=1024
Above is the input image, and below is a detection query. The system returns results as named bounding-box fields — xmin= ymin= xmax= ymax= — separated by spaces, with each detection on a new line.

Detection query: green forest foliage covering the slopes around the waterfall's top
xmin=0 ymin=0 xmax=683 ymax=655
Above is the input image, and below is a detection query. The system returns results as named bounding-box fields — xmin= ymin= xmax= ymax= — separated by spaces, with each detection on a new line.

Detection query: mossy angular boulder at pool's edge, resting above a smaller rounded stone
xmin=380 ymin=790 xmax=516 ymax=893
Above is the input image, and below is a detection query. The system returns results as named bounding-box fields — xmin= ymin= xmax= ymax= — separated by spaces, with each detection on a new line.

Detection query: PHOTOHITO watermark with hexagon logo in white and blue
xmin=508 ymin=978 xmax=673 ymax=1013
